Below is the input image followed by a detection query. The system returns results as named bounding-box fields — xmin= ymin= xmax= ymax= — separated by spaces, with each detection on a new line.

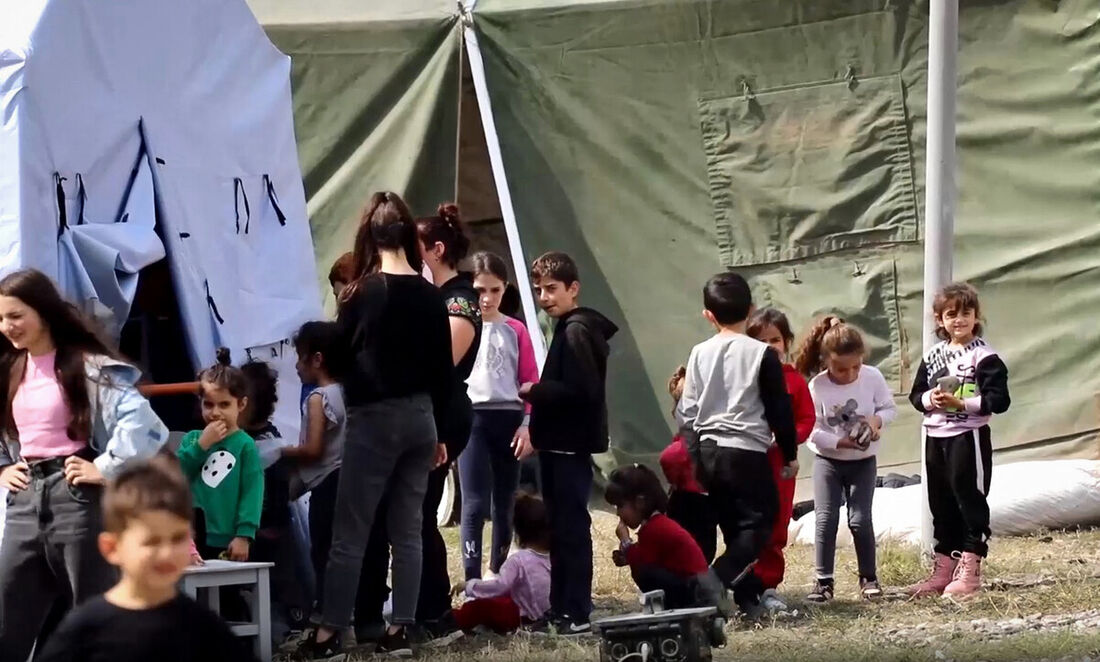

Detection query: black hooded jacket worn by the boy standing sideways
xmin=527 ymin=308 xmax=618 ymax=453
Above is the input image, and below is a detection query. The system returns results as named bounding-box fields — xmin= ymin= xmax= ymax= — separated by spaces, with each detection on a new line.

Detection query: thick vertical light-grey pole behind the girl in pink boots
xmin=921 ymin=0 xmax=959 ymax=554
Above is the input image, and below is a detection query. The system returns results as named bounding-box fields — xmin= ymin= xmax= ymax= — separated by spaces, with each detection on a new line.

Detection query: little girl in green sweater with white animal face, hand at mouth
xmin=177 ymin=347 xmax=264 ymax=561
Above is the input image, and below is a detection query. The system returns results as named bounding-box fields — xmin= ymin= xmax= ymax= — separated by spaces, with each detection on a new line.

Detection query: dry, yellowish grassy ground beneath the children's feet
xmin=305 ymin=514 xmax=1100 ymax=662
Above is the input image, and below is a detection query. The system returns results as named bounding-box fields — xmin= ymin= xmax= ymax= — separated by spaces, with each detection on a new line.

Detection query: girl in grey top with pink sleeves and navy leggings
xmin=459 ymin=253 xmax=539 ymax=580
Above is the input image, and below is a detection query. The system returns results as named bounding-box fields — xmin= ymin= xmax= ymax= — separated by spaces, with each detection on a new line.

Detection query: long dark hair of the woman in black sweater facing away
xmin=341 ymin=191 xmax=424 ymax=301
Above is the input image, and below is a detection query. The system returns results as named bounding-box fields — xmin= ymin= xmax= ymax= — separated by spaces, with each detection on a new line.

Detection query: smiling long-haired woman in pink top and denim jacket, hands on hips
xmin=0 ymin=269 xmax=168 ymax=660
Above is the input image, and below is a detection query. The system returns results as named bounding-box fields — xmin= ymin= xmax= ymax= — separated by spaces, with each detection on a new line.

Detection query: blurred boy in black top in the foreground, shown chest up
xmin=37 ymin=455 xmax=252 ymax=662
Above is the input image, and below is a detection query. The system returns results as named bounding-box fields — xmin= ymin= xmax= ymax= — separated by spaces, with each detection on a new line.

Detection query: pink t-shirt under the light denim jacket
xmin=11 ymin=352 xmax=87 ymax=460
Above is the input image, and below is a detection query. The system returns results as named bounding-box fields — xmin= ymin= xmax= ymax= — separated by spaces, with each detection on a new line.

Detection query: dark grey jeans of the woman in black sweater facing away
xmin=322 ymin=395 xmax=437 ymax=630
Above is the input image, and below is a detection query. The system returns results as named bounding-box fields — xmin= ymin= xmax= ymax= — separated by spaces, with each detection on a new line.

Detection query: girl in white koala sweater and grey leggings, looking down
xmin=795 ymin=316 xmax=898 ymax=603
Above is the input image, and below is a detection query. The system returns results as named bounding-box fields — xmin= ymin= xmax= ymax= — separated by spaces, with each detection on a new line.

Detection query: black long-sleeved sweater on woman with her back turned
xmin=337 ymin=274 xmax=454 ymax=428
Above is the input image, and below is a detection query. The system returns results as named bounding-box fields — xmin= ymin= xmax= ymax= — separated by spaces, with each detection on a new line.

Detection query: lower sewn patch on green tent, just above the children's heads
xmin=751 ymin=255 xmax=912 ymax=393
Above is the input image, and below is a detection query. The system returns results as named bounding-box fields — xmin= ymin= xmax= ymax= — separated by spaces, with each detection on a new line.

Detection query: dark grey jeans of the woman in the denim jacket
xmin=0 ymin=462 xmax=118 ymax=662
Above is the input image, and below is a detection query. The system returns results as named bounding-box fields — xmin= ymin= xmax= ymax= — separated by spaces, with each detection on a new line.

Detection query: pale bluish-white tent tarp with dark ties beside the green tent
xmin=0 ymin=0 xmax=322 ymax=434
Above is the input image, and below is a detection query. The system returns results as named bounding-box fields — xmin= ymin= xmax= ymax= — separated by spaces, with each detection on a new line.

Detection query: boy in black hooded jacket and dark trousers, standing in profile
xmin=520 ymin=253 xmax=618 ymax=636
